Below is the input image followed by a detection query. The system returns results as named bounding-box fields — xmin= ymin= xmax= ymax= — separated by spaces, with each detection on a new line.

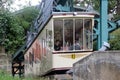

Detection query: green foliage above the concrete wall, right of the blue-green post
xmin=109 ymin=29 xmax=120 ymax=50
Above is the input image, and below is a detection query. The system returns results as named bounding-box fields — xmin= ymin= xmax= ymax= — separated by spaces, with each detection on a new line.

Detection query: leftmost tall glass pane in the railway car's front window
xmin=54 ymin=19 xmax=63 ymax=51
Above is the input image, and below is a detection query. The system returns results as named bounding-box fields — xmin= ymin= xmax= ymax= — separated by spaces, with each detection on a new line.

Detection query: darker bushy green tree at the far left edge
xmin=0 ymin=10 xmax=24 ymax=53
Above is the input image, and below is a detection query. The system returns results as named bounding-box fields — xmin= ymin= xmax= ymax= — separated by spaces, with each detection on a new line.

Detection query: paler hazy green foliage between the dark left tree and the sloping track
xmin=16 ymin=6 xmax=39 ymax=31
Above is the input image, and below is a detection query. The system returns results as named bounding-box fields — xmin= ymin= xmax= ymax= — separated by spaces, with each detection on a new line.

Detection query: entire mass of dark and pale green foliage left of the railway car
xmin=0 ymin=7 xmax=38 ymax=54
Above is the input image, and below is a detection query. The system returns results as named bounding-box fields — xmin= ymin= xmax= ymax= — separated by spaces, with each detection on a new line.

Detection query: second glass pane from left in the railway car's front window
xmin=64 ymin=19 xmax=73 ymax=50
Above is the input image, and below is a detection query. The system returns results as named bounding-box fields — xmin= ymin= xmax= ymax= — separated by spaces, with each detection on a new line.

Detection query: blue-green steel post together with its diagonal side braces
xmin=93 ymin=0 xmax=120 ymax=49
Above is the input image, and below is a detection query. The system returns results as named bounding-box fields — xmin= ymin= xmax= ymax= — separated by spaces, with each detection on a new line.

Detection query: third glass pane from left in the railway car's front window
xmin=75 ymin=19 xmax=83 ymax=50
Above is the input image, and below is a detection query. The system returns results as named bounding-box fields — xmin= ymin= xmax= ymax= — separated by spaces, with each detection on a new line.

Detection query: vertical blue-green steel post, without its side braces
xmin=98 ymin=0 xmax=108 ymax=48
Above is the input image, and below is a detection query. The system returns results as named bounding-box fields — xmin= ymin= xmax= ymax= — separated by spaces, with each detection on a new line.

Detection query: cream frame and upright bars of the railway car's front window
xmin=53 ymin=17 xmax=93 ymax=51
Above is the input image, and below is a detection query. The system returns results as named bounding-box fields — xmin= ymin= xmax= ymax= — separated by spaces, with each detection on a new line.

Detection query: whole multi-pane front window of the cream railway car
xmin=54 ymin=18 xmax=92 ymax=51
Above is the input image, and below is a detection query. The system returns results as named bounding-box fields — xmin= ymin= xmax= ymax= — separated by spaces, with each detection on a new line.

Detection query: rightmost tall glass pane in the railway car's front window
xmin=84 ymin=19 xmax=92 ymax=49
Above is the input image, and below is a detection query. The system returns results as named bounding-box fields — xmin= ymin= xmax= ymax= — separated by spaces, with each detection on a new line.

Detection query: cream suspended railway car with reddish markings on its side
xmin=24 ymin=12 xmax=94 ymax=76
